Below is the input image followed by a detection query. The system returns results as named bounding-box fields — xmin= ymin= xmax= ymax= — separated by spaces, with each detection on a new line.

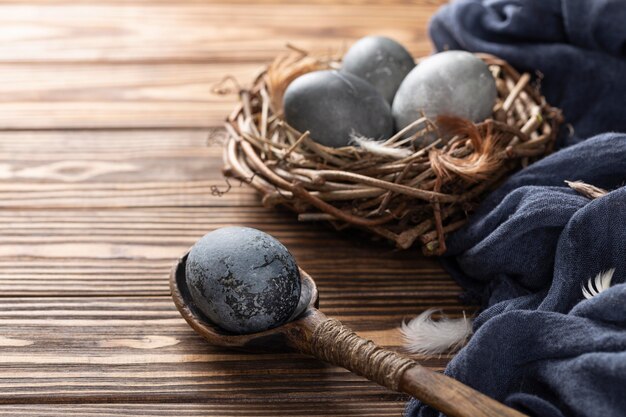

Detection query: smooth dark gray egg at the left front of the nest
xmin=283 ymin=70 xmax=393 ymax=148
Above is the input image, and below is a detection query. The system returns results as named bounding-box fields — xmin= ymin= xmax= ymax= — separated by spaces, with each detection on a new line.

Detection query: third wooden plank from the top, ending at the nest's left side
xmin=0 ymin=130 xmax=259 ymax=208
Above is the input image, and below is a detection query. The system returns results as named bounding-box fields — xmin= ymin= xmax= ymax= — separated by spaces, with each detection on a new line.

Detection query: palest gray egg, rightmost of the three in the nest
xmin=392 ymin=51 xmax=497 ymax=130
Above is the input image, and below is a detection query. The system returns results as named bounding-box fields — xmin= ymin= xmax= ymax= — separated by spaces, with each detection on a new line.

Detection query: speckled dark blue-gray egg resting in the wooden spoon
xmin=185 ymin=227 xmax=300 ymax=334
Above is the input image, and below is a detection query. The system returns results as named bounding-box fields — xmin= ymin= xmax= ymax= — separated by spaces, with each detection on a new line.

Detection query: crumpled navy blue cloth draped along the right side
xmin=406 ymin=0 xmax=626 ymax=417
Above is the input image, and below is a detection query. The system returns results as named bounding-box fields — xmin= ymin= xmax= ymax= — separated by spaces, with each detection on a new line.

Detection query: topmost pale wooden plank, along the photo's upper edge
xmin=0 ymin=2 xmax=438 ymax=63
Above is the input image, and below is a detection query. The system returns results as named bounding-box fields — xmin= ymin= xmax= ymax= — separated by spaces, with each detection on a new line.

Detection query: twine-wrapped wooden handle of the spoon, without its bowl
xmin=287 ymin=309 xmax=525 ymax=417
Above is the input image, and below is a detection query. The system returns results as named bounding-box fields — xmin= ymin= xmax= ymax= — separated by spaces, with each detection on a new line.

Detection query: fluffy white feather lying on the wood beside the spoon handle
xmin=400 ymin=309 xmax=472 ymax=355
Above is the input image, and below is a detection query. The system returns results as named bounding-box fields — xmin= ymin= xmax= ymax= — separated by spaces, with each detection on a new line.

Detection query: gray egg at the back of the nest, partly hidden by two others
xmin=341 ymin=36 xmax=415 ymax=104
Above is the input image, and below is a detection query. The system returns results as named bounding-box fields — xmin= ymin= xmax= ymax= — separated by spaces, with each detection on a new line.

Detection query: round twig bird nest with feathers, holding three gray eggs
xmin=224 ymin=53 xmax=562 ymax=255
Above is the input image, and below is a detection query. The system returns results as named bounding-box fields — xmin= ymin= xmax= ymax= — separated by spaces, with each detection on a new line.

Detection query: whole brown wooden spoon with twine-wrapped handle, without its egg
xmin=170 ymin=255 xmax=525 ymax=417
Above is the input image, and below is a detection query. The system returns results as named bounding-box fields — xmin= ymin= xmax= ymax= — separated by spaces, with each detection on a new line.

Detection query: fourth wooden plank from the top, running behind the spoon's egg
xmin=0 ymin=207 xmax=460 ymax=300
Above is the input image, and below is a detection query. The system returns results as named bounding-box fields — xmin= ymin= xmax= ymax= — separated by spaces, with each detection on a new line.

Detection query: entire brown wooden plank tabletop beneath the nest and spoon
xmin=0 ymin=0 xmax=464 ymax=416
